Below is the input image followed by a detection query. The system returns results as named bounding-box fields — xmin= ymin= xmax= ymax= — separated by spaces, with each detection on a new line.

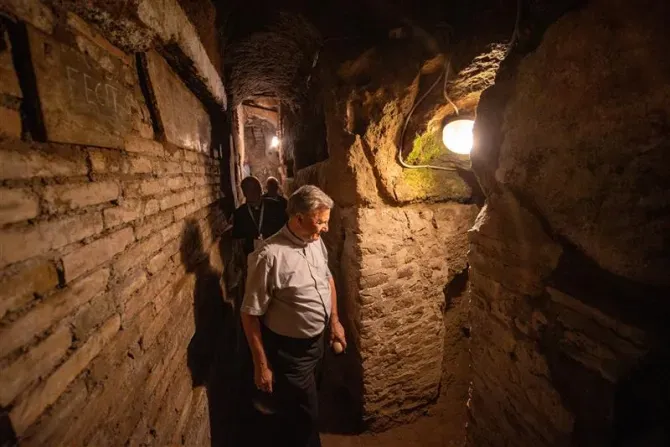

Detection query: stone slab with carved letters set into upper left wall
xmin=29 ymin=25 xmax=143 ymax=147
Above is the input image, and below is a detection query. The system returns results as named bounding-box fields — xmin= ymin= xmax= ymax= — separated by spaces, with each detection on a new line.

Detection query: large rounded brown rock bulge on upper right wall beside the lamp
xmin=495 ymin=2 xmax=670 ymax=286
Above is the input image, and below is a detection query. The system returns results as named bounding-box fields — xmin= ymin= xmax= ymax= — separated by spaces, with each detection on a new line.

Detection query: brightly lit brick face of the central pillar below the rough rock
xmin=348 ymin=203 xmax=478 ymax=428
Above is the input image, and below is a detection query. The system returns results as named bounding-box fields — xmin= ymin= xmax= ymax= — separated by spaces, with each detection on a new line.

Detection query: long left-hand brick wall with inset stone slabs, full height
xmin=0 ymin=2 xmax=227 ymax=445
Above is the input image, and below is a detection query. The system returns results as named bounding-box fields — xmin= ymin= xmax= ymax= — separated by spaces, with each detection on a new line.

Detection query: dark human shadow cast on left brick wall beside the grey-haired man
xmin=180 ymin=220 xmax=237 ymax=446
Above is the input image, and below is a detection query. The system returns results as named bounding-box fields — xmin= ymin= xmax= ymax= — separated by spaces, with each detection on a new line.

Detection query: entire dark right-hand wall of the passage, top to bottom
xmin=468 ymin=1 xmax=670 ymax=447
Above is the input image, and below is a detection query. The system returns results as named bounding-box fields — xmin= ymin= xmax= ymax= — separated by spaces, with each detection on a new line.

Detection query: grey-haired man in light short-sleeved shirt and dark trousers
xmin=241 ymin=186 xmax=346 ymax=447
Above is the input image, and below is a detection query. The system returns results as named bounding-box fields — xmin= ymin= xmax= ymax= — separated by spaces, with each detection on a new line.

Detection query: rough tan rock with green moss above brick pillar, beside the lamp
xmin=322 ymin=41 xmax=498 ymax=203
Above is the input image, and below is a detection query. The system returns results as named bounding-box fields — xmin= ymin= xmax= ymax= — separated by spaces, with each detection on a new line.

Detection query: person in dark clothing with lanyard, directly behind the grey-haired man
xmin=232 ymin=176 xmax=287 ymax=256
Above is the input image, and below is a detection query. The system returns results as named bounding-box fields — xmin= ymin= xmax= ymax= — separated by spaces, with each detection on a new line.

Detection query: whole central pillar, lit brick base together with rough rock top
xmin=285 ymin=34 xmax=497 ymax=430
